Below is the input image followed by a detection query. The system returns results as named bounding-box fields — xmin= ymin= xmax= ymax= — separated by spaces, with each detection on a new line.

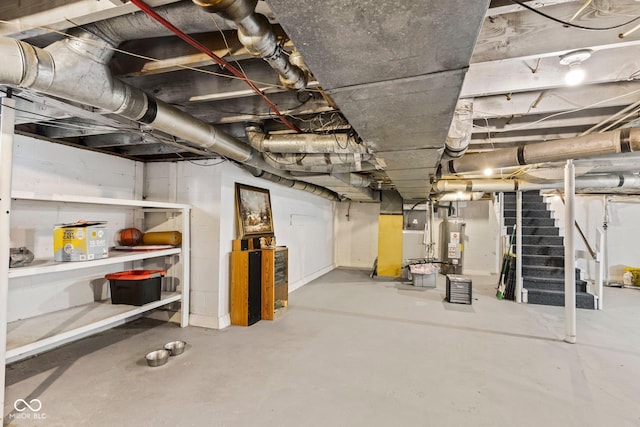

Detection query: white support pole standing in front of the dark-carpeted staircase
xmin=564 ymin=160 xmax=576 ymax=344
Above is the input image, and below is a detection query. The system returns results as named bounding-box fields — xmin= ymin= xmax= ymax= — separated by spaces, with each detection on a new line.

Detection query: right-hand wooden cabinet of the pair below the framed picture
xmin=262 ymin=247 xmax=289 ymax=320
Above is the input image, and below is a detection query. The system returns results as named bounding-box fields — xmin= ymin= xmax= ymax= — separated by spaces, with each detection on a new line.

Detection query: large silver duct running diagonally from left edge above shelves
xmin=0 ymin=33 xmax=340 ymax=200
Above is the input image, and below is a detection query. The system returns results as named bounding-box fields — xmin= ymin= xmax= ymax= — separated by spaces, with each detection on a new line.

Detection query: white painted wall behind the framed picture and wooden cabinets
xmin=145 ymin=161 xmax=334 ymax=328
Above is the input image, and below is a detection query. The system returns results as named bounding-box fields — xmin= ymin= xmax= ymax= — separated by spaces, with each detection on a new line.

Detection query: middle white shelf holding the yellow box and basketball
xmin=9 ymin=248 xmax=182 ymax=278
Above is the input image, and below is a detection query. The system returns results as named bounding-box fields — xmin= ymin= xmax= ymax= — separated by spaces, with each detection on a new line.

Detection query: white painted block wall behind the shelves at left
xmin=8 ymin=135 xmax=143 ymax=321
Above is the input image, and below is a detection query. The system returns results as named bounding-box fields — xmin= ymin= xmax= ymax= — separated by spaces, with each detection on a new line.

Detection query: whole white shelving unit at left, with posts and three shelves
xmin=0 ymin=98 xmax=191 ymax=418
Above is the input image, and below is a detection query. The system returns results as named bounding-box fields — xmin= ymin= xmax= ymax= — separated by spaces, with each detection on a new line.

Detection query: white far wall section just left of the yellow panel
xmin=335 ymin=202 xmax=380 ymax=269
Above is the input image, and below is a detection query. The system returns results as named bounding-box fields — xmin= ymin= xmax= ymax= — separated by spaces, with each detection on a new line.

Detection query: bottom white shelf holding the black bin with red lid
xmin=6 ymin=292 xmax=182 ymax=363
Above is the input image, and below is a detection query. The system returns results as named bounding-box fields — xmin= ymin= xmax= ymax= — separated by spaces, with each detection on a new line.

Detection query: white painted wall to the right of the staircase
xmin=548 ymin=194 xmax=640 ymax=283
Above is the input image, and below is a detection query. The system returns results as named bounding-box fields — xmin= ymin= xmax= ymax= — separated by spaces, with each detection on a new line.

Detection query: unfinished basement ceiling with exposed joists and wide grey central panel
xmin=0 ymin=0 xmax=640 ymax=201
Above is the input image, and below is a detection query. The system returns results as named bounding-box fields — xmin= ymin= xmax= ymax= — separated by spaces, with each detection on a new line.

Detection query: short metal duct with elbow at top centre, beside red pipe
xmin=193 ymin=0 xmax=307 ymax=90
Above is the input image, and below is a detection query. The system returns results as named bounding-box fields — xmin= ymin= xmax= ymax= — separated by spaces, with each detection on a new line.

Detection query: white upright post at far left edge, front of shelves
xmin=0 ymin=98 xmax=16 ymax=420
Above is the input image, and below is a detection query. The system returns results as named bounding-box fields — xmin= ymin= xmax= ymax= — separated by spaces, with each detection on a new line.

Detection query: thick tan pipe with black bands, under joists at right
xmin=440 ymin=128 xmax=640 ymax=174
